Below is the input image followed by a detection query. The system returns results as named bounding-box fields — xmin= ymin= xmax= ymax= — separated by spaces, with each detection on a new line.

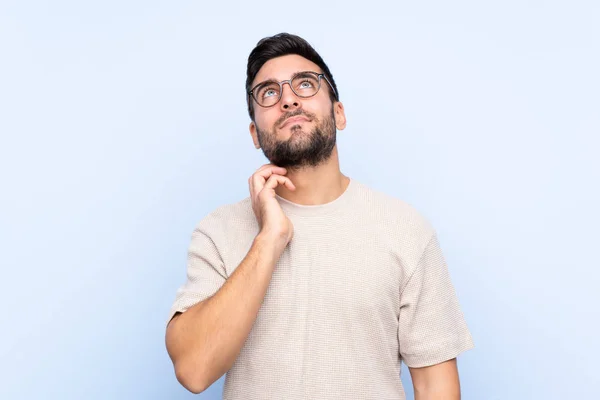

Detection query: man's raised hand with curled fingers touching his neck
xmin=248 ymin=164 xmax=296 ymax=247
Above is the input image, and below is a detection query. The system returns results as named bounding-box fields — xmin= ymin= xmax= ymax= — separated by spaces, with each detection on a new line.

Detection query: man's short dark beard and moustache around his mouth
xmin=256 ymin=107 xmax=336 ymax=170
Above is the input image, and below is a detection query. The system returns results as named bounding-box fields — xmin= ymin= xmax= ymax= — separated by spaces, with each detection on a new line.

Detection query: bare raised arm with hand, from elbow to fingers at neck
xmin=165 ymin=165 xmax=295 ymax=393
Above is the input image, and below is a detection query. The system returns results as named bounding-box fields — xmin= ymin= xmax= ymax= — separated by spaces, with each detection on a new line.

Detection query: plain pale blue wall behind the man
xmin=0 ymin=0 xmax=600 ymax=400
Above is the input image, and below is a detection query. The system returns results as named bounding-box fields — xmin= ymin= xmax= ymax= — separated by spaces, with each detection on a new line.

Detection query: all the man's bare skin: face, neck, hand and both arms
xmin=165 ymin=55 xmax=460 ymax=400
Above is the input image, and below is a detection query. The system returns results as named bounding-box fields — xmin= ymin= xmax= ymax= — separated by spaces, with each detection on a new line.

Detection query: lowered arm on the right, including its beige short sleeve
xmin=398 ymin=232 xmax=474 ymax=400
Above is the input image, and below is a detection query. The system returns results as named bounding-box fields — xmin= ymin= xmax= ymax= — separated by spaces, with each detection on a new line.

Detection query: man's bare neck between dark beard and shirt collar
xmin=275 ymin=146 xmax=350 ymax=205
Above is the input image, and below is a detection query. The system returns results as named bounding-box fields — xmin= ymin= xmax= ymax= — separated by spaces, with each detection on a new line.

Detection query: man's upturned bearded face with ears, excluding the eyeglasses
xmin=250 ymin=54 xmax=346 ymax=170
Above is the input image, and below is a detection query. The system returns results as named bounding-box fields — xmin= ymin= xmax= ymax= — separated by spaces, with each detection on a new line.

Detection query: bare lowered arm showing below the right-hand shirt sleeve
xmin=409 ymin=358 xmax=460 ymax=400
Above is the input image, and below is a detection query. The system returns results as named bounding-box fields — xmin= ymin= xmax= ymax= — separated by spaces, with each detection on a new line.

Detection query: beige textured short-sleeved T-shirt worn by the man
xmin=169 ymin=180 xmax=474 ymax=400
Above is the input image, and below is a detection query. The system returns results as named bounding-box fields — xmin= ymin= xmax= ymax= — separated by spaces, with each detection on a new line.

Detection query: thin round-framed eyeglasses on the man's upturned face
xmin=248 ymin=71 xmax=336 ymax=107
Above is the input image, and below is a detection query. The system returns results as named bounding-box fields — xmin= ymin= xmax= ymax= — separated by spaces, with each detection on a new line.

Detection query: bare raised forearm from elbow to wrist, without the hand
xmin=167 ymin=235 xmax=282 ymax=393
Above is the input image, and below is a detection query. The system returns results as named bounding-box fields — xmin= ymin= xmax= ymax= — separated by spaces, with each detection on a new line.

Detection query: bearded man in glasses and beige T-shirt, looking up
xmin=166 ymin=34 xmax=473 ymax=400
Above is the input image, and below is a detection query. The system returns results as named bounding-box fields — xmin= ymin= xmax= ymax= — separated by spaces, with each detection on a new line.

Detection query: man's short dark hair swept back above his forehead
xmin=246 ymin=33 xmax=339 ymax=120
